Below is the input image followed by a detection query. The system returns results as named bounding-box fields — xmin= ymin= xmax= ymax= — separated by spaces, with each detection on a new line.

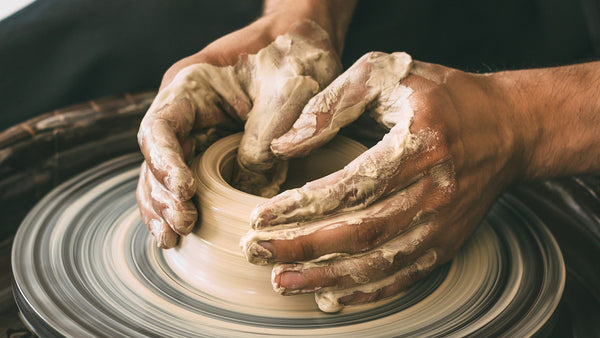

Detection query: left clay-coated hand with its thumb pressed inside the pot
xmin=137 ymin=20 xmax=341 ymax=248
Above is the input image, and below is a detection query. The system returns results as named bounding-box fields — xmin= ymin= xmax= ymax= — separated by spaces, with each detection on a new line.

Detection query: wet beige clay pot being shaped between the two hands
xmin=164 ymin=134 xmax=366 ymax=317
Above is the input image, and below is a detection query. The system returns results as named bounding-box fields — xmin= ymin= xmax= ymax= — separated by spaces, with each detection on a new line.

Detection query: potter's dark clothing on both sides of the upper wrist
xmin=0 ymin=0 xmax=600 ymax=130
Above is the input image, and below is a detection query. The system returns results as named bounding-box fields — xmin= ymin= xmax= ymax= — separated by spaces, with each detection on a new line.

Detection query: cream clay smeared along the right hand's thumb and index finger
xmin=252 ymin=53 xmax=425 ymax=228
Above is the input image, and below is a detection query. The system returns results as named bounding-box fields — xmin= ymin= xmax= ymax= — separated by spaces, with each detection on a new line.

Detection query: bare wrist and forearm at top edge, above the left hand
xmin=263 ymin=0 xmax=357 ymax=55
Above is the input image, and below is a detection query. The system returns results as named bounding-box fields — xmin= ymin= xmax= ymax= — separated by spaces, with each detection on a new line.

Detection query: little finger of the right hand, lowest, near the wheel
xmin=315 ymin=249 xmax=442 ymax=312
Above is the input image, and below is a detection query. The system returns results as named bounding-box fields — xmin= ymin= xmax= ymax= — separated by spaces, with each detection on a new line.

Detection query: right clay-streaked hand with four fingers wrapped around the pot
xmin=242 ymin=52 xmax=518 ymax=312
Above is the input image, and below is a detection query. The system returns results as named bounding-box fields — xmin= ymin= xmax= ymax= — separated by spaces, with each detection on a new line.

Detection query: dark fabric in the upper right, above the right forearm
xmin=343 ymin=0 xmax=600 ymax=72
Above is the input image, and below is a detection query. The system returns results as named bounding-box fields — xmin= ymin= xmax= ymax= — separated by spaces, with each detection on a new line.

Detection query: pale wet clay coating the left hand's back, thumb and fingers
xmin=139 ymin=21 xmax=341 ymax=246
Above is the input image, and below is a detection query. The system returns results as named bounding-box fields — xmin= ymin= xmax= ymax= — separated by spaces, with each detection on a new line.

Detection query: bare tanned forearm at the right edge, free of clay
xmin=492 ymin=62 xmax=600 ymax=179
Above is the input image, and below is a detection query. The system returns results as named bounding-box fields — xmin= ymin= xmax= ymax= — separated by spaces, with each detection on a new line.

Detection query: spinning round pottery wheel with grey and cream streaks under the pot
xmin=12 ymin=136 xmax=565 ymax=337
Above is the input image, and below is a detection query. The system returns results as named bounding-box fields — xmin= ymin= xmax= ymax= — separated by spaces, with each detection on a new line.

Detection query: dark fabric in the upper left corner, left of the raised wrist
xmin=0 ymin=0 xmax=262 ymax=130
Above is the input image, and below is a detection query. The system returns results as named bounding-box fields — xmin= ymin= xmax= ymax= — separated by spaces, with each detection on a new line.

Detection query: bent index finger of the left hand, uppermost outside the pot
xmin=138 ymin=99 xmax=195 ymax=200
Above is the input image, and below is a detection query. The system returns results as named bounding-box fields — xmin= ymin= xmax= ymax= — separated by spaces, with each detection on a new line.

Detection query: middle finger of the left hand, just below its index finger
xmin=142 ymin=165 xmax=198 ymax=235
